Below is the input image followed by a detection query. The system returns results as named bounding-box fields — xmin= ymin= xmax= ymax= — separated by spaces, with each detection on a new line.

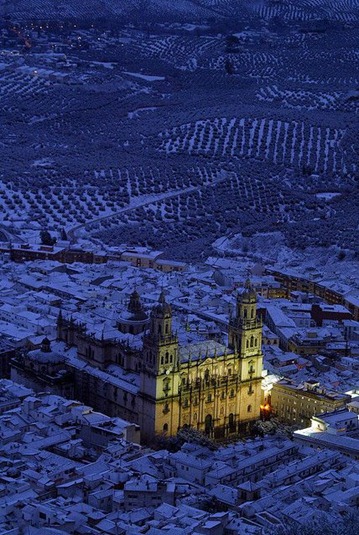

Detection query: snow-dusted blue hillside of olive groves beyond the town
xmin=0 ymin=0 xmax=359 ymax=260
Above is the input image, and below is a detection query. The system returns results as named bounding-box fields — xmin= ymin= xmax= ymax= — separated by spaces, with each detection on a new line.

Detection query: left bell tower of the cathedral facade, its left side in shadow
xmin=140 ymin=291 xmax=179 ymax=436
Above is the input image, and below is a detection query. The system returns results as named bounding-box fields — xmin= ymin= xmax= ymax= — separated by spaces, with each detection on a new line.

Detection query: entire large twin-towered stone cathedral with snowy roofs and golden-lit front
xmin=15 ymin=281 xmax=263 ymax=442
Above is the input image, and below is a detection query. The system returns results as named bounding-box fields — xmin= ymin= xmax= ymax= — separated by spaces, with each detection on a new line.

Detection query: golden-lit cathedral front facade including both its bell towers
xmin=140 ymin=283 xmax=263 ymax=438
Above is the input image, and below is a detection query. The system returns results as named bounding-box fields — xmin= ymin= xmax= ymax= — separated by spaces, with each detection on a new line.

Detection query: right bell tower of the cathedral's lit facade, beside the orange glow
xmin=228 ymin=279 xmax=263 ymax=430
